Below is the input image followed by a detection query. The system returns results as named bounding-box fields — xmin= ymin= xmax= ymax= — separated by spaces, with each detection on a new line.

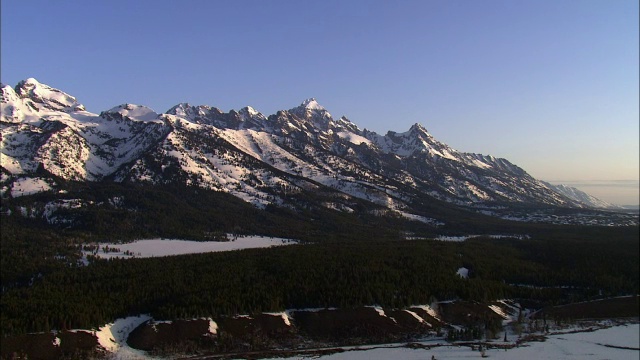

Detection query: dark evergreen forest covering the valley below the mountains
xmin=0 ymin=186 xmax=640 ymax=335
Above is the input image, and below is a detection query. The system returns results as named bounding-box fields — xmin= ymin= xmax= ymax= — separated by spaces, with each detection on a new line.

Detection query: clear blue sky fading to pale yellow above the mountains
xmin=1 ymin=0 xmax=640 ymax=204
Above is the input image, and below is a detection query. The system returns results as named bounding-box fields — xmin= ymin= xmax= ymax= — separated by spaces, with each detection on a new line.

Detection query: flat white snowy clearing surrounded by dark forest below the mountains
xmin=84 ymin=236 xmax=298 ymax=259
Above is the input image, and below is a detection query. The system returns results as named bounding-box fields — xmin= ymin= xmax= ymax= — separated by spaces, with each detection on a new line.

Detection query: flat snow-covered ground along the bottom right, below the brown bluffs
xmin=281 ymin=324 xmax=640 ymax=360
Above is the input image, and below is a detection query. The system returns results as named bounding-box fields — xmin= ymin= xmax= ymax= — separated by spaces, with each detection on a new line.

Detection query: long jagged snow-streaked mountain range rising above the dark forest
xmin=1 ymin=79 xmax=591 ymax=217
